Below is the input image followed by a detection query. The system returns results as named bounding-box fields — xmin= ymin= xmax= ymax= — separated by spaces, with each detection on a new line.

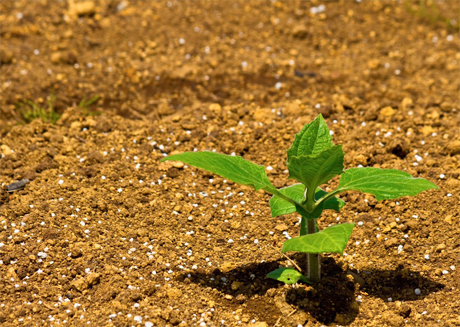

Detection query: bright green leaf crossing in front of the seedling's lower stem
xmin=281 ymin=224 xmax=355 ymax=254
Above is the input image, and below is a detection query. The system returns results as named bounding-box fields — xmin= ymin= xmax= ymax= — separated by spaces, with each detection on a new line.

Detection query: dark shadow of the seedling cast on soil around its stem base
xmin=178 ymin=256 xmax=444 ymax=325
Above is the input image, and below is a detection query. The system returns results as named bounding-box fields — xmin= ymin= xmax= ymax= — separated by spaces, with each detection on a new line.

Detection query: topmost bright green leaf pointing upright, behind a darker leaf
xmin=287 ymin=114 xmax=334 ymax=162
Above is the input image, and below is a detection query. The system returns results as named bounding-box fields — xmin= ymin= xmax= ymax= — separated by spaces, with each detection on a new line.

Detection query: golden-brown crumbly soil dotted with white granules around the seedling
xmin=0 ymin=0 xmax=460 ymax=327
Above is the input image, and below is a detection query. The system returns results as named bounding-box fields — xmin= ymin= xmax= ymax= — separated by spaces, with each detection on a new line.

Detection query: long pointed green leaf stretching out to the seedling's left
xmin=161 ymin=151 xmax=277 ymax=193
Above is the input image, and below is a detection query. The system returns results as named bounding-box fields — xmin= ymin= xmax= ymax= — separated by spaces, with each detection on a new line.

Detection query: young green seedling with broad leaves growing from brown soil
xmin=161 ymin=115 xmax=438 ymax=284
